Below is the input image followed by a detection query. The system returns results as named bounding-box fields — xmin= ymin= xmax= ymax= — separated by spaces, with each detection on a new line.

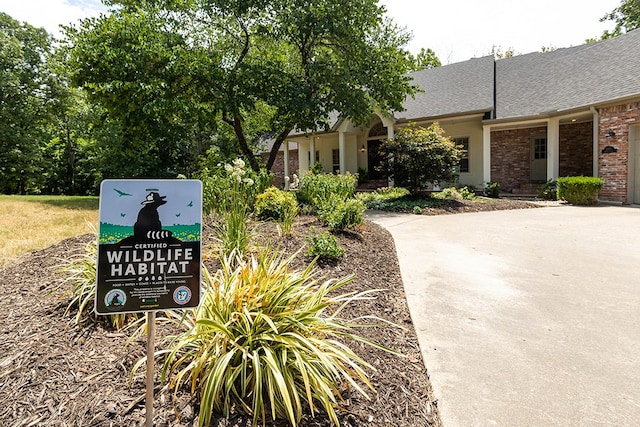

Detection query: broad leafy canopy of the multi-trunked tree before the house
xmin=69 ymin=0 xmax=415 ymax=174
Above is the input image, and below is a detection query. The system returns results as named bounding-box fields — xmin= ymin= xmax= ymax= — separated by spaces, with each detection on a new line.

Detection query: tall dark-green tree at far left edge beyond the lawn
xmin=0 ymin=13 xmax=54 ymax=194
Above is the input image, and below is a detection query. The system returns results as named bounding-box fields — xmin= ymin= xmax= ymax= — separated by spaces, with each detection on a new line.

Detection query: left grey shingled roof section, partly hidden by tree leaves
xmin=395 ymin=56 xmax=494 ymax=120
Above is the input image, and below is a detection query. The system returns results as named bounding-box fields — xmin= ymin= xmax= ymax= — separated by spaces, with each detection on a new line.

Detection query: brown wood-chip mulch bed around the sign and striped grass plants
xmin=0 ymin=200 xmax=535 ymax=427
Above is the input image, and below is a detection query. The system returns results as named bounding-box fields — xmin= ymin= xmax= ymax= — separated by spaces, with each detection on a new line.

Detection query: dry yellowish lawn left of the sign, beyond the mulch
xmin=0 ymin=195 xmax=99 ymax=268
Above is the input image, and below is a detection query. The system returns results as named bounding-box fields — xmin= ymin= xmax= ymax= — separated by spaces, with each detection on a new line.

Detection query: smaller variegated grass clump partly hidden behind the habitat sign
xmin=59 ymin=239 xmax=138 ymax=329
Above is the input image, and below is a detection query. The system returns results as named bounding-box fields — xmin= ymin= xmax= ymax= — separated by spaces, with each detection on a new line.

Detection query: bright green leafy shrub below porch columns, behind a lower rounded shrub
xmin=297 ymin=173 xmax=358 ymax=209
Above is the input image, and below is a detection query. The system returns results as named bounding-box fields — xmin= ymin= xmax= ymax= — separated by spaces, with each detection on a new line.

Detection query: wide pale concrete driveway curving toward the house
xmin=368 ymin=206 xmax=640 ymax=427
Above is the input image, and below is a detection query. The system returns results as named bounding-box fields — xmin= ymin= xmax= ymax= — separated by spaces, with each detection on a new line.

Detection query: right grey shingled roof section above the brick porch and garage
xmin=496 ymin=30 xmax=640 ymax=119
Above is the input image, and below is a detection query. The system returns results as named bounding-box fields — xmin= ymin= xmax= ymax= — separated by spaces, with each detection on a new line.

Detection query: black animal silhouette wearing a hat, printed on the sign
xmin=120 ymin=191 xmax=180 ymax=243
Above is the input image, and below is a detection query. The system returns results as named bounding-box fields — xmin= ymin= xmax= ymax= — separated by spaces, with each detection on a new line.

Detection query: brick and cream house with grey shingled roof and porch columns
xmin=285 ymin=30 xmax=640 ymax=204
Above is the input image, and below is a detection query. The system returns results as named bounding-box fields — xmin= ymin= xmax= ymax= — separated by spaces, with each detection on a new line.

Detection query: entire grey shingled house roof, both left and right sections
xmin=395 ymin=30 xmax=640 ymax=121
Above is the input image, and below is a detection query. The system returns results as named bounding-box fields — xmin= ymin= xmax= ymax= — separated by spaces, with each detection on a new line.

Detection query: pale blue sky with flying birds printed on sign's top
xmin=100 ymin=180 xmax=202 ymax=227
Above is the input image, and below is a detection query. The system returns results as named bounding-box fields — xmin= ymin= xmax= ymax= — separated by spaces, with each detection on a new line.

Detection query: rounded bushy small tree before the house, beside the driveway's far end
xmin=381 ymin=123 xmax=463 ymax=192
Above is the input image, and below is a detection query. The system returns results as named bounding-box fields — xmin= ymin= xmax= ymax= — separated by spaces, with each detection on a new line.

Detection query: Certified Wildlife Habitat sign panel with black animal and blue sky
xmin=95 ymin=180 xmax=202 ymax=314
